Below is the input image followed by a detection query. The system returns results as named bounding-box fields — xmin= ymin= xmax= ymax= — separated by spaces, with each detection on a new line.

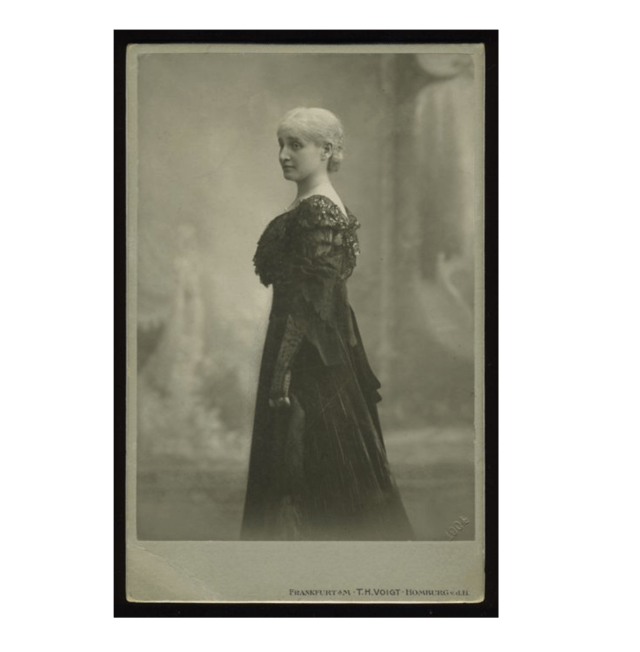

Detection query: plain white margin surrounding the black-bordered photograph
xmin=2 ymin=8 xmax=638 ymax=632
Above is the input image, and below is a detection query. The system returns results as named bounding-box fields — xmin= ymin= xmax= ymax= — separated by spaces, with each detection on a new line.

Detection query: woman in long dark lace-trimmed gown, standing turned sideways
xmin=241 ymin=108 xmax=412 ymax=541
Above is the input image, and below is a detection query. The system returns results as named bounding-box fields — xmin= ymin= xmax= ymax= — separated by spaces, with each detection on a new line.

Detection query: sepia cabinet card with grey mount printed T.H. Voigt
xmin=127 ymin=45 xmax=484 ymax=602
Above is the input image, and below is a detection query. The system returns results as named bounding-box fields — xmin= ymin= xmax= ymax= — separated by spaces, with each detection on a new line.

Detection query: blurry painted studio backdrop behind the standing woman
xmin=132 ymin=53 xmax=481 ymax=540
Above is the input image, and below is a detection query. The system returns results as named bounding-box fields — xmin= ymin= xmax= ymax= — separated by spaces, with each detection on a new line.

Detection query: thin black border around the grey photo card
xmin=113 ymin=29 xmax=499 ymax=618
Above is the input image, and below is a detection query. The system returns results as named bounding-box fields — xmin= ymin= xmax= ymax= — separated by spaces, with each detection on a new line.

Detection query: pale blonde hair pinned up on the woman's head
xmin=278 ymin=107 xmax=344 ymax=172
